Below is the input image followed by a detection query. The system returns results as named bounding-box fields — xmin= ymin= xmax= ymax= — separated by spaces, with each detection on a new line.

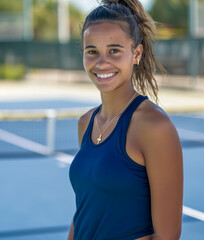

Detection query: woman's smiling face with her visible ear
xmin=83 ymin=22 xmax=142 ymax=92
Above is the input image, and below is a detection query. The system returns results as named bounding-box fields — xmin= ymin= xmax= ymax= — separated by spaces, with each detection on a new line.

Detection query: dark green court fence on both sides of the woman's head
xmin=0 ymin=39 xmax=204 ymax=76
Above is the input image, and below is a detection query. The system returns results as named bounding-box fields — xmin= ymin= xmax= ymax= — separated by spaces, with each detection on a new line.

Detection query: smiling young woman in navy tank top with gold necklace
xmin=68 ymin=0 xmax=183 ymax=240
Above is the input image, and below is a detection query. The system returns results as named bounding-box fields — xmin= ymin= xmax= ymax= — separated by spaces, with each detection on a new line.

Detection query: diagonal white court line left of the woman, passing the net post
xmin=0 ymin=129 xmax=74 ymax=167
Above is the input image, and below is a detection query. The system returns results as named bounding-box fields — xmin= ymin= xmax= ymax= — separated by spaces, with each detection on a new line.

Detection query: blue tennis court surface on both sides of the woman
xmin=0 ymin=99 xmax=204 ymax=240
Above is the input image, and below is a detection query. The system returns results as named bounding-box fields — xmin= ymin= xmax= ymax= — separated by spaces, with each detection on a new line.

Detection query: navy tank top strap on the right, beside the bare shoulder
xmin=118 ymin=95 xmax=148 ymax=151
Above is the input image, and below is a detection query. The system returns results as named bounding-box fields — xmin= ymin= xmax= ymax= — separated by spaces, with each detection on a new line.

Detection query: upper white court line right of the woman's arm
xmin=177 ymin=128 xmax=204 ymax=141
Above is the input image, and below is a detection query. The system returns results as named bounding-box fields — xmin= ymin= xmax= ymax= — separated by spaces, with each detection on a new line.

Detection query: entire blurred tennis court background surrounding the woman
xmin=0 ymin=0 xmax=204 ymax=240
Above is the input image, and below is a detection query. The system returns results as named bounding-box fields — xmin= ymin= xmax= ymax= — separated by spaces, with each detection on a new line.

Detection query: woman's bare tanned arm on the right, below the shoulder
xmin=143 ymin=113 xmax=183 ymax=240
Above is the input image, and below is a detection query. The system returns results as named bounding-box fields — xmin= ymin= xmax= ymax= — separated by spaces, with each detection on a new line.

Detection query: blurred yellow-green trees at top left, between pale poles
xmin=0 ymin=0 xmax=84 ymax=41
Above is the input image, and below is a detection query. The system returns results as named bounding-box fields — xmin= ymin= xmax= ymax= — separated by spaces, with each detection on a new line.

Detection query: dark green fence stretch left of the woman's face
xmin=0 ymin=41 xmax=83 ymax=70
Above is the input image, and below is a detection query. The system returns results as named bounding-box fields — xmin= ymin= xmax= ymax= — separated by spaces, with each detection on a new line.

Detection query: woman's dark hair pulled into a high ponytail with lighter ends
xmin=82 ymin=0 xmax=164 ymax=102
